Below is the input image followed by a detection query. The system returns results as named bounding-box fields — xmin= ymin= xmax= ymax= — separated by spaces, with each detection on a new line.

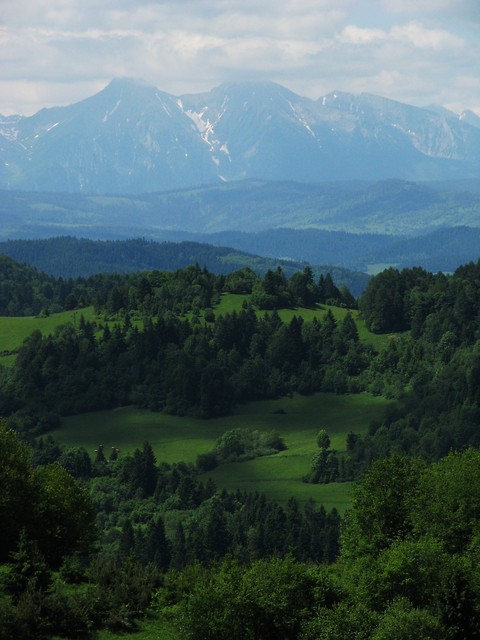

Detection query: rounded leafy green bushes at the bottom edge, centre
xmin=156 ymin=558 xmax=328 ymax=640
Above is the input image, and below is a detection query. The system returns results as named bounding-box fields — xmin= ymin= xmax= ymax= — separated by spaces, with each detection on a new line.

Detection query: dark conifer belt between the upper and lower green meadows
xmin=0 ymin=307 xmax=371 ymax=428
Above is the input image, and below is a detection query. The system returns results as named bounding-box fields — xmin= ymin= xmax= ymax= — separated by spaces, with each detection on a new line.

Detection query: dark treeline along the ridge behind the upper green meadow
xmin=0 ymin=251 xmax=356 ymax=316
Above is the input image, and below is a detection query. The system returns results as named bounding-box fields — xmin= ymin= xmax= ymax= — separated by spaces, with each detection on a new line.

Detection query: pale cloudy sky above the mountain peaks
xmin=0 ymin=0 xmax=480 ymax=115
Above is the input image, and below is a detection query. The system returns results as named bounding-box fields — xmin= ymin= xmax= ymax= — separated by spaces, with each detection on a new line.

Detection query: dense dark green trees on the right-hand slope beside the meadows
xmin=351 ymin=262 xmax=480 ymax=470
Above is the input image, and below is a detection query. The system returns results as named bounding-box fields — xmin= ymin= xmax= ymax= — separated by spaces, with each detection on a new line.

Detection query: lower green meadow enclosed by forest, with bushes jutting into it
xmin=52 ymin=393 xmax=388 ymax=512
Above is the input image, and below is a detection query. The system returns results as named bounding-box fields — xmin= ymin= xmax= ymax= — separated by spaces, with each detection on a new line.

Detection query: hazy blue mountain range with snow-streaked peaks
xmin=0 ymin=79 xmax=480 ymax=194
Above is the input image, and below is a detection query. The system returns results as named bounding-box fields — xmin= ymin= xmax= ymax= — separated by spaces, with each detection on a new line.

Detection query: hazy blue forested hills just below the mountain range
xmin=0 ymin=180 xmax=480 ymax=276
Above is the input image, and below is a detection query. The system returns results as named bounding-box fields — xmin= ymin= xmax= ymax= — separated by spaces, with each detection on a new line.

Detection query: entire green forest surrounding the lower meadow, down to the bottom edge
xmin=0 ymin=252 xmax=480 ymax=640
